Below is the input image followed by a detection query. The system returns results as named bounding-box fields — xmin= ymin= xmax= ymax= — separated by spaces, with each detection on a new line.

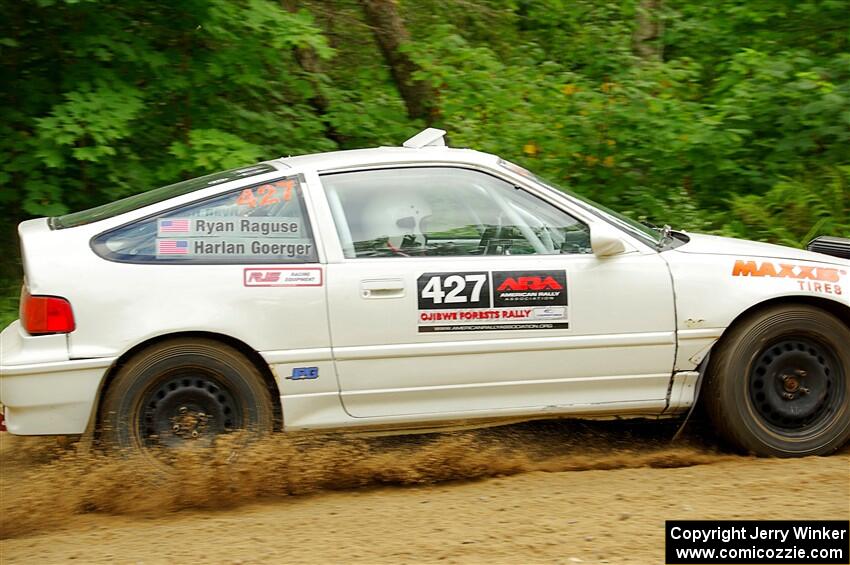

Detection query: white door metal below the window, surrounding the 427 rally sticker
xmin=328 ymin=254 xmax=675 ymax=417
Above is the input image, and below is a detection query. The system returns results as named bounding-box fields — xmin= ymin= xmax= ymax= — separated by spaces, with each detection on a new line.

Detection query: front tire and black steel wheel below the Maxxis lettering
xmin=705 ymin=305 xmax=850 ymax=457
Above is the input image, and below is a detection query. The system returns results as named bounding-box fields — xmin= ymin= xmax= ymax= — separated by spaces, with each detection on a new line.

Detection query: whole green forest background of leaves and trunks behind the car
xmin=0 ymin=0 xmax=850 ymax=327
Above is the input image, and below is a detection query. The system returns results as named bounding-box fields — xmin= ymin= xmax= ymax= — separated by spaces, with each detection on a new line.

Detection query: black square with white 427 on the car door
xmin=416 ymin=271 xmax=490 ymax=310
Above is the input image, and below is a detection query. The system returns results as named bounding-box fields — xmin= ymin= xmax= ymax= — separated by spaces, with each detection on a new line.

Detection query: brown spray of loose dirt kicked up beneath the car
xmin=0 ymin=421 xmax=737 ymax=539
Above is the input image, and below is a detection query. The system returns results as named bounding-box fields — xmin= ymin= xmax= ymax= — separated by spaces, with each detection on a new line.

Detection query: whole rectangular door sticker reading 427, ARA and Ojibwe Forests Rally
xmin=417 ymin=271 xmax=569 ymax=333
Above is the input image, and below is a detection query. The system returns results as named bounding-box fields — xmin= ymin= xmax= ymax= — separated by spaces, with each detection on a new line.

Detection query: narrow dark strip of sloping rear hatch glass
xmin=50 ymin=164 xmax=276 ymax=230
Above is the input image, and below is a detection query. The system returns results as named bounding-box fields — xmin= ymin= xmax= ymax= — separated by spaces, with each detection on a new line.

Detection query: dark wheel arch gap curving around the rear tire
xmin=86 ymin=331 xmax=283 ymax=435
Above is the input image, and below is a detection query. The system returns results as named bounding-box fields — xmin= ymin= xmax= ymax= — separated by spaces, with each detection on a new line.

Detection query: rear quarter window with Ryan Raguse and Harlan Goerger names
xmin=92 ymin=177 xmax=317 ymax=264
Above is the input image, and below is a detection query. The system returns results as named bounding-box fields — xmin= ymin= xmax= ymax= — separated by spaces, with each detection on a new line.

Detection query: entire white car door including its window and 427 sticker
xmin=321 ymin=165 xmax=675 ymax=421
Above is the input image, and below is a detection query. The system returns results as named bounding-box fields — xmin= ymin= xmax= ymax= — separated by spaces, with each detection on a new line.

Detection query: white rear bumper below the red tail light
xmin=0 ymin=322 xmax=114 ymax=435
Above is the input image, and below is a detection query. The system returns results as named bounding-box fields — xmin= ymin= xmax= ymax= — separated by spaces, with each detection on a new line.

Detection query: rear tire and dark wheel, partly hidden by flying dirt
xmin=101 ymin=338 xmax=274 ymax=454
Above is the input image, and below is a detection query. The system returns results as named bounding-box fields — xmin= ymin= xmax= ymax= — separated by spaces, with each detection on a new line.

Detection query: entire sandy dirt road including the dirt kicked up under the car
xmin=0 ymin=422 xmax=850 ymax=564
